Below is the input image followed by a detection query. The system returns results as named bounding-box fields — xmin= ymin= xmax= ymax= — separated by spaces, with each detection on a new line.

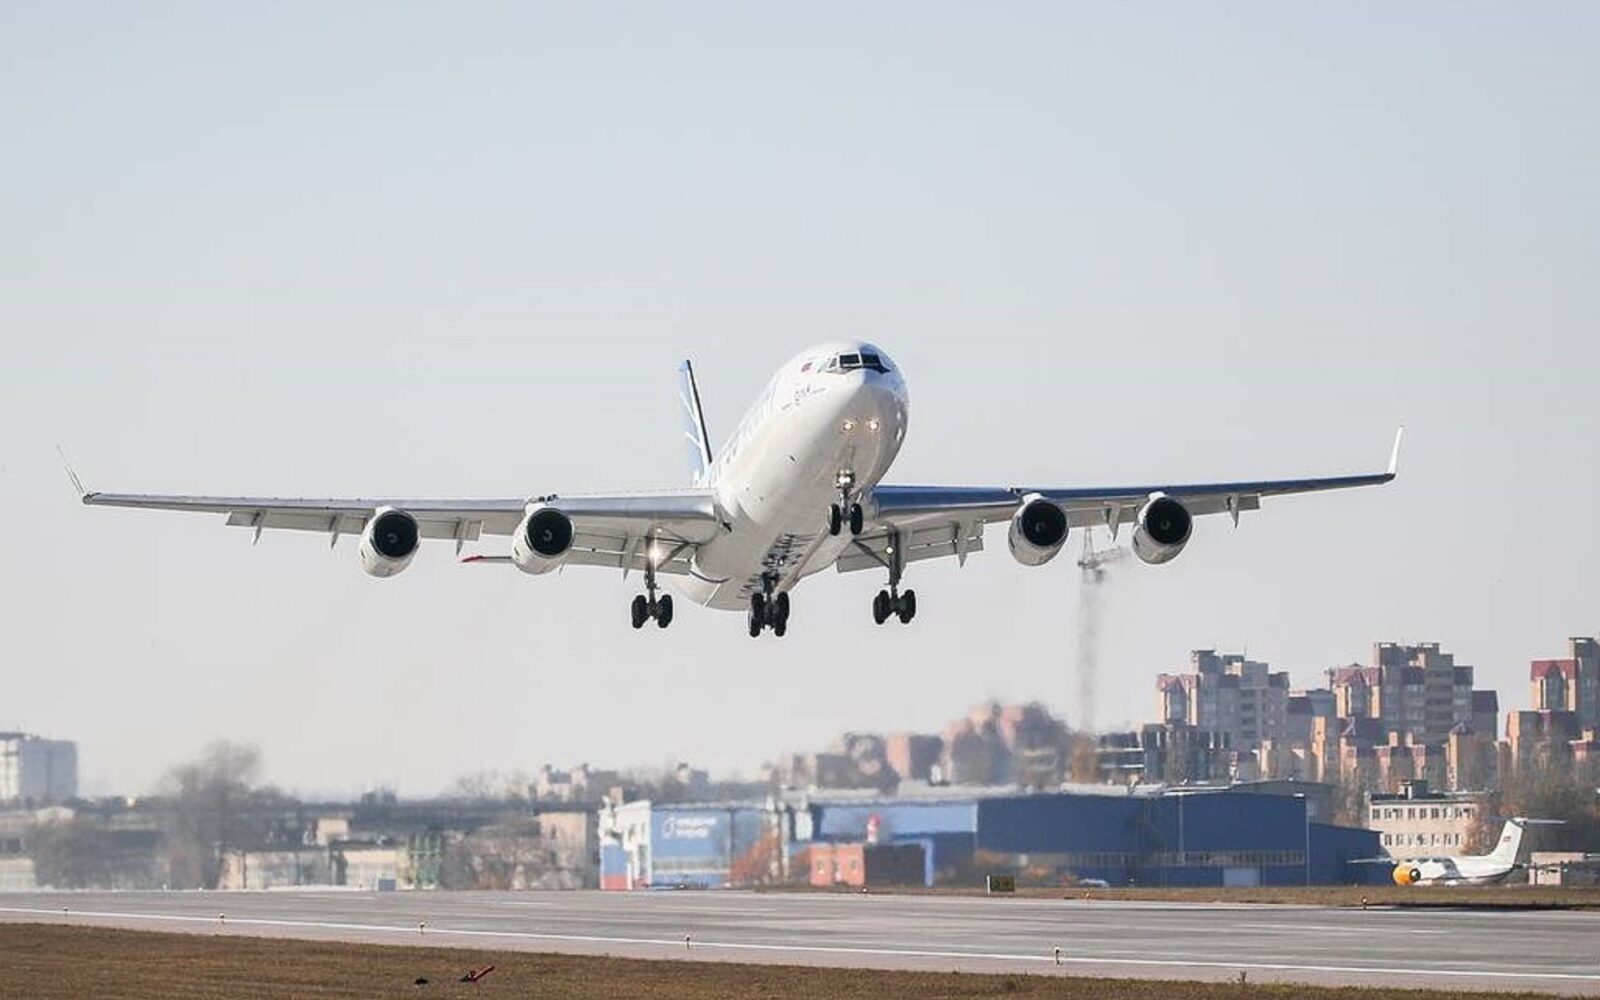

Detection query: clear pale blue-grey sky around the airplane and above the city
xmin=0 ymin=3 xmax=1600 ymax=794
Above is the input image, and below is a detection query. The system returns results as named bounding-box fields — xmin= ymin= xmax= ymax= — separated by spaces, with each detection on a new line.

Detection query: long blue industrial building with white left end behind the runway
xmin=600 ymin=789 xmax=1381 ymax=888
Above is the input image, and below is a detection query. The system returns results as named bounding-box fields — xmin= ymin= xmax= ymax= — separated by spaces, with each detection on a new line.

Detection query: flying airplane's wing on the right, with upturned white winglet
xmin=838 ymin=429 xmax=1403 ymax=573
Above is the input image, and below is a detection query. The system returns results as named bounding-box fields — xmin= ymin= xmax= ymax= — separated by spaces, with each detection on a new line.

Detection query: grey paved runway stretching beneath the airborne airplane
xmin=0 ymin=891 xmax=1600 ymax=994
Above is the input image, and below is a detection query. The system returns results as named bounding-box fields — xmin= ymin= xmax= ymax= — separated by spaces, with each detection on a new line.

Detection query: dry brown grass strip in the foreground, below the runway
xmin=0 ymin=923 xmax=1561 ymax=1000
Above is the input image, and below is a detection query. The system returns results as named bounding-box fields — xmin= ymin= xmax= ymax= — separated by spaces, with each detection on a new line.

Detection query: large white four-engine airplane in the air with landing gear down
xmin=80 ymin=342 xmax=1400 ymax=637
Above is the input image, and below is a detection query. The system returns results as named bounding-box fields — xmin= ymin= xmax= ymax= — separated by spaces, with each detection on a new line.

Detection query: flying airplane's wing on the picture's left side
xmin=83 ymin=490 xmax=720 ymax=574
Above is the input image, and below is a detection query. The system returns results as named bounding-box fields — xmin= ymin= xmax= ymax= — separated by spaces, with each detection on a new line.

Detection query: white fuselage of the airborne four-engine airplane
xmin=670 ymin=342 xmax=909 ymax=610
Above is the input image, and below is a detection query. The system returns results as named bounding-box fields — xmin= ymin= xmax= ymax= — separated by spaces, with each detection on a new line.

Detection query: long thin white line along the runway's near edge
xmin=0 ymin=906 xmax=1600 ymax=982
